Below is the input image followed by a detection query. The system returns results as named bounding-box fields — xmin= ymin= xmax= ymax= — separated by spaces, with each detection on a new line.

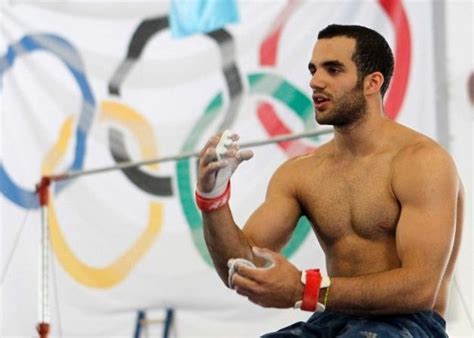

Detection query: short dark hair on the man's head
xmin=318 ymin=25 xmax=394 ymax=97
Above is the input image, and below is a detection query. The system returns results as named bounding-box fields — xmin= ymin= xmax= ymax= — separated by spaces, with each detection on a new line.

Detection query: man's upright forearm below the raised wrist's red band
xmin=203 ymin=205 xmax=253 ymax=285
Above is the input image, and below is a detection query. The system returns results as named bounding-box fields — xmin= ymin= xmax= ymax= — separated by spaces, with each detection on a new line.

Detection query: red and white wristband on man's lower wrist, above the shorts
xmin=294 ymin=269 xmax=331 ymax=312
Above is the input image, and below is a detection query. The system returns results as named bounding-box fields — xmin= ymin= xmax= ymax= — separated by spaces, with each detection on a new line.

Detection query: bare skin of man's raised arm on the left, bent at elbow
xmin=198 ymin=136 xmax=301 ymax=285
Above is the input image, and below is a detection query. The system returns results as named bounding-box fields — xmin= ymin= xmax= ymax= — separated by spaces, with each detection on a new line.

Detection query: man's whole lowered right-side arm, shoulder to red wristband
xmin=328 ymin=145 xmax=459 ymax=314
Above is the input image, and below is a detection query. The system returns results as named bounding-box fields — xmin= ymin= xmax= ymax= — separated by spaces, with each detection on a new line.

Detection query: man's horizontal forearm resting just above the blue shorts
xmin=326 ymin=268 xmax=439 ymax=314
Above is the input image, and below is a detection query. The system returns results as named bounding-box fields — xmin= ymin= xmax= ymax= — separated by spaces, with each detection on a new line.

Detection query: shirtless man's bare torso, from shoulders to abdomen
xmin=288 ymin=123 xmax=462 ymax=315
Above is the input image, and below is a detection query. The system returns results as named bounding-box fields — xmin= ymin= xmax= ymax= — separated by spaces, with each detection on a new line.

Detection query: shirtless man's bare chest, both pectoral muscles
xmin=301 ymin=161 xmax=400 ymax=244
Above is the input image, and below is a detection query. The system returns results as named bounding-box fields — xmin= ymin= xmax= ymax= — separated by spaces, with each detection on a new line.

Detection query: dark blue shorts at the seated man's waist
xmin=262 ymin=311 xmax=448 ymax=338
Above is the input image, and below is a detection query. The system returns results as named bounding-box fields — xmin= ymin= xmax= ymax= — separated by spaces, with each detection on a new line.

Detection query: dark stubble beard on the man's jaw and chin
xmin=316 ymin=81 xmax=367 ymax=129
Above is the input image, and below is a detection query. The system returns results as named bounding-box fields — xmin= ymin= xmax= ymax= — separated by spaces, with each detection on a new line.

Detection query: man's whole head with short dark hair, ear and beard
xmin=308 ymin=25 xmax=393 ymax=127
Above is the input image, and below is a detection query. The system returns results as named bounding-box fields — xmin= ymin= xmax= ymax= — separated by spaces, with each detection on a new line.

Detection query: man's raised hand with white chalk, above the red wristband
xmin=197 ymin=130 xmax=253 ymax=198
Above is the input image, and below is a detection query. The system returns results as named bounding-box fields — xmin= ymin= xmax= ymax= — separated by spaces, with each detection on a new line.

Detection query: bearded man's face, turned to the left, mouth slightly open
xmin=308 ymin=37 xmax=367 ymax=127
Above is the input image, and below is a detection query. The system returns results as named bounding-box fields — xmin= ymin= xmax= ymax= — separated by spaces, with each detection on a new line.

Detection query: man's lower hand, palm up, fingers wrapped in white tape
xmin=232 ymin=247 xmax=304 ymax=308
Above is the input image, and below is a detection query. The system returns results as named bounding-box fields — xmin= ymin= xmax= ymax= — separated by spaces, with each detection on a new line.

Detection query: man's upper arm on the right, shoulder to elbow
xmin=394 ymin=149 xmax=458 ymax=283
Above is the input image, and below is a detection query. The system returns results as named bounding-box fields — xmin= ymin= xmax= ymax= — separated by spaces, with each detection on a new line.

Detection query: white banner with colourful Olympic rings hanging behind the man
xmin=0 ymin=0 xmax=436 ymax=337
